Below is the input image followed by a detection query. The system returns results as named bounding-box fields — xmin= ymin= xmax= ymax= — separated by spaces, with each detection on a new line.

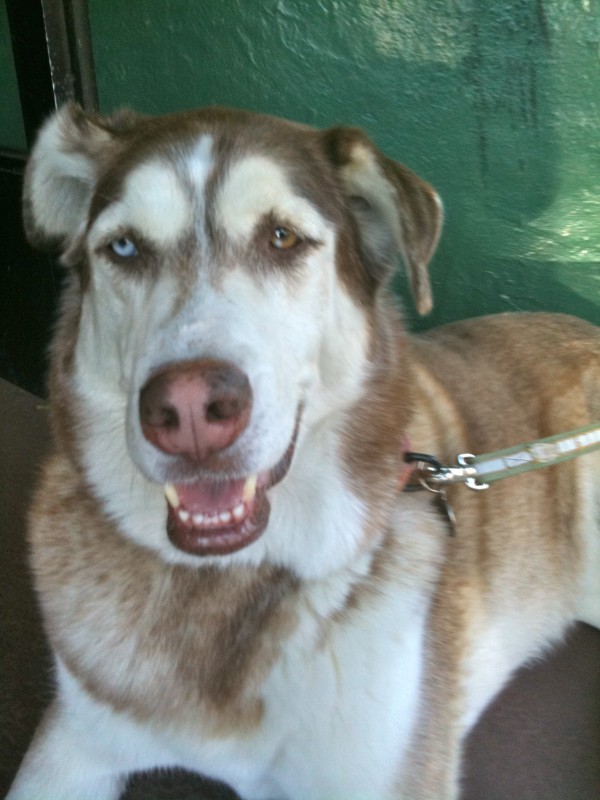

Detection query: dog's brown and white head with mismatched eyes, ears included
xmin=25 ymin=106 xmax=441 ymax=568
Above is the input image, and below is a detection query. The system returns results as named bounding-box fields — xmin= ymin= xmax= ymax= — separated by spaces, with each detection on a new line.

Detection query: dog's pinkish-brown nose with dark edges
xmin=139 ymin=359 xmax=252 ymax=463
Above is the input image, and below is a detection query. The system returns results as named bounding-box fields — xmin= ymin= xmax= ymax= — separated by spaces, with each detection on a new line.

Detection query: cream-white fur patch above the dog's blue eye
xmin=94 ymin=160 xmax=192 ymax=245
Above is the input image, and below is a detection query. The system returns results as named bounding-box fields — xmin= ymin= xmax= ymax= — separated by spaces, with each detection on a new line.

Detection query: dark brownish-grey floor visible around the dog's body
xmin=0 ymin=380 xmax=600 ymax=800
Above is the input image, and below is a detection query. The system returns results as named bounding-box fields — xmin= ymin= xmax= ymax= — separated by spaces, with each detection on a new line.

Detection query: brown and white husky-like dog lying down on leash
xmin=9 ymin=105 xmax=600 ymax=800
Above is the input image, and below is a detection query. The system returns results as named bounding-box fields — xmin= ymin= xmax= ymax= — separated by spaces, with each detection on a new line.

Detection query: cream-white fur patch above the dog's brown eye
xmin=215 ymin=155 xmax=325 ymax=241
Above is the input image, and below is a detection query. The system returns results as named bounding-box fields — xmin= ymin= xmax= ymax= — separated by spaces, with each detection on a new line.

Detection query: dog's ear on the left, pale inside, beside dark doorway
xmin=23 ymin=103 xmax=134 ymax=250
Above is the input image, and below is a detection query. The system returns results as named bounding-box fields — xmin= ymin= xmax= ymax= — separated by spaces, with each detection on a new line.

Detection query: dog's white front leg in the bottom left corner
xmin=6 ymin=702 xmax=125 ymax=800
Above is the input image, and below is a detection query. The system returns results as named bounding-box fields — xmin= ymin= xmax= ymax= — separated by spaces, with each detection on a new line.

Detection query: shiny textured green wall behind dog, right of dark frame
xmin=35 ymin=0 xmax=600 ymax=325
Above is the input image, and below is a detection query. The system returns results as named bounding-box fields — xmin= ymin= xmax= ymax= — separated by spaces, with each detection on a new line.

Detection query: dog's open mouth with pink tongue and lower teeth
xmin=164 ymin=415 xmax=300 ymax=556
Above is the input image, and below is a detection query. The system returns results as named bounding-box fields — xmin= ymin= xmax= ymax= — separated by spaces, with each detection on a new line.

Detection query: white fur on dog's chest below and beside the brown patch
xmin=54 ymin=564 xmax=424 ymax=800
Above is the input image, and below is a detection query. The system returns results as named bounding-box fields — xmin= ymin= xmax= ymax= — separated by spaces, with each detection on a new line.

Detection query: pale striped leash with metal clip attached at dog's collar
xmin=399 ymin=422 xmax=600 ymax=534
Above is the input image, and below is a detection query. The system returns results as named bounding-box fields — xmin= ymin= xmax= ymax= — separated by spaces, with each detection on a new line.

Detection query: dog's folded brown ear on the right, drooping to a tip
xmin=322 ymin=128 xmax=443 ymax=314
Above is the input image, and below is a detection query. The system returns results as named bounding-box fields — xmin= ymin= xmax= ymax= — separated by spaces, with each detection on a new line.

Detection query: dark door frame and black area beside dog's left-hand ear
xmin=0 ymin=0 xmax=97 ymax=395
